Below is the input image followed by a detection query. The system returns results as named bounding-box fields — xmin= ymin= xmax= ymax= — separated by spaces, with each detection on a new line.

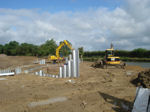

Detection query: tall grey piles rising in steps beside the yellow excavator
xmin=59 ymin=50 xmax=80 ymax=78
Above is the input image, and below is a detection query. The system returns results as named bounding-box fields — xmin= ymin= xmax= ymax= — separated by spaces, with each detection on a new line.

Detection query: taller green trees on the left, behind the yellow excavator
xmin=0 ymin=39 xmax=70 ymax=56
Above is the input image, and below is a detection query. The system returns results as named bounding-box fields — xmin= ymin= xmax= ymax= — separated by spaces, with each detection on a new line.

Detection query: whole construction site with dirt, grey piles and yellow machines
xmin=0 ymin=40 xmax=150 ymax=112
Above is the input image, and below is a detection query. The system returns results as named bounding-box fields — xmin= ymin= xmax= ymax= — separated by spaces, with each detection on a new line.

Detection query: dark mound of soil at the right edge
xmin=132 ymin=69 xmax=150 ymax=88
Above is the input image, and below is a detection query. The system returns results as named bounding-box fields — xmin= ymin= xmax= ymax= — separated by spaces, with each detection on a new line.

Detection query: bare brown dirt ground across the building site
xmin=0 ymin=56 xmax=144 ymax=112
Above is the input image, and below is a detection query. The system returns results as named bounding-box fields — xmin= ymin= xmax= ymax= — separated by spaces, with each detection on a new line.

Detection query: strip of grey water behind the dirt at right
xmin=126 ymin=62 xmax=150 ymax=68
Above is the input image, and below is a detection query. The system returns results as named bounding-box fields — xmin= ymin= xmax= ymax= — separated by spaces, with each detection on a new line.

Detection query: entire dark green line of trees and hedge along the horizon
xmin=0 ymin=39 xmax=150 ymax=58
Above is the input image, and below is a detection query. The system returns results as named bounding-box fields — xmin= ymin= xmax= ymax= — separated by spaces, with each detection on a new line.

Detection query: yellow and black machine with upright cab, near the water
xmin=92 ymin=44 xmax=126 ymax=68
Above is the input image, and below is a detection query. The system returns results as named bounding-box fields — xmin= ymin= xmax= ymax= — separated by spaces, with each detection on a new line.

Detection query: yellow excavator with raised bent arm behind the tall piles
xmin=48 ymin=40 xmax=73 ymax=63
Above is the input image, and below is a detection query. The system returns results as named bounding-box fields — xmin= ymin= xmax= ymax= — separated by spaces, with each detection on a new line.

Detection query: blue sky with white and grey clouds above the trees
xmin=0 ymin=0 xmax=150 ymax=51
